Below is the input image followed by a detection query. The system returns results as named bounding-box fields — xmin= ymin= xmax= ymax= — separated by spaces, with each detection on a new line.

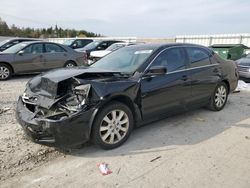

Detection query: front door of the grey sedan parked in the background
xmin=15 ymin=43 xmax=44 ymax=73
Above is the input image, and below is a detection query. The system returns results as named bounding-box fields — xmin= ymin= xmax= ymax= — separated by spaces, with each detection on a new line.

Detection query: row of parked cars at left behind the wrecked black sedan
xmin=0 ymin=38 xmax=135 ymax=80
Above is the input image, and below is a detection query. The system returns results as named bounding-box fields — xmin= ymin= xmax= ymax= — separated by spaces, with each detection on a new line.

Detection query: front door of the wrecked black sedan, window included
xmin=141 ymin=47 xmax=191 ymax=120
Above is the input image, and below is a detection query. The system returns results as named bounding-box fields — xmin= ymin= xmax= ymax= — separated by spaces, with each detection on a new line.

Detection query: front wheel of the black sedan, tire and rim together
xmin=92 ymin=102 xmax=134 ymax=149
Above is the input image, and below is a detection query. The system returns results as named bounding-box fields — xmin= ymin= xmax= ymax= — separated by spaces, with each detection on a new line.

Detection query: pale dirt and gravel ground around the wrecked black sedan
xmin=0 ymin=76 xmax=250 ymax=188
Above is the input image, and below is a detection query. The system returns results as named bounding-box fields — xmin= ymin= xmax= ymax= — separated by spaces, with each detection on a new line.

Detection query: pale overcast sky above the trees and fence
xmin=0 ymin=0 xmax=250 ymax=37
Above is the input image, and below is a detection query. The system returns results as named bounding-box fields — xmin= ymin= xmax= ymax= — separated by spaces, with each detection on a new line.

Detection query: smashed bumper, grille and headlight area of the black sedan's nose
xmin=17 ymin=76 xmax=95 ymax=145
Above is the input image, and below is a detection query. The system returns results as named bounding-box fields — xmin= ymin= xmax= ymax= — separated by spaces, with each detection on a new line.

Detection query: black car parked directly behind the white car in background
xmin=76 ymin=40 xmax=122 ymax=58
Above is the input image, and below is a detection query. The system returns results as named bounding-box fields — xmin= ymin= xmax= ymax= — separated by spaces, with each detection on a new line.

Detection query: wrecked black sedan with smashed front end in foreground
xmin=16 ymin=44 xmax=238 ymax=149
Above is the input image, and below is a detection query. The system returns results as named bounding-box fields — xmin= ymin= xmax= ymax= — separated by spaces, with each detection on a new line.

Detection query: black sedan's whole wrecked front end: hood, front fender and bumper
xmin=16 ymin=68 xmax=139 ymax=146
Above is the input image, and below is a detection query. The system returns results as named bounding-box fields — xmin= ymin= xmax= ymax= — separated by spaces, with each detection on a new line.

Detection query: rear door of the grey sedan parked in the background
xmin=44 ymin=43 xmax=68 ymax=70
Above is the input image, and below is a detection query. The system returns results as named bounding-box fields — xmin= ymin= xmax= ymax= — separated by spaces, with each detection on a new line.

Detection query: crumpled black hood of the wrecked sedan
xmin=27 ymin=67 xmax=137 ymax=104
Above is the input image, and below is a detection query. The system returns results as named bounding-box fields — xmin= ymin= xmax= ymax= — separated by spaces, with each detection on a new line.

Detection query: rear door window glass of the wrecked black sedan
xmin=186 ymin=47 xmax=211 ymax=67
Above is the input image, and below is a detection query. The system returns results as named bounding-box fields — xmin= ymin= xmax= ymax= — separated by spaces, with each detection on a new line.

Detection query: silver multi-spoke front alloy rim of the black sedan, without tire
xmin=99 ymin=110 xmax=129 ymax=144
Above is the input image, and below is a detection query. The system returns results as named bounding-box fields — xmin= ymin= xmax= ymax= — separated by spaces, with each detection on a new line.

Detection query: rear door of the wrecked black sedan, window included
xmin=185 ymin=47 xmax=220 ymax=105
